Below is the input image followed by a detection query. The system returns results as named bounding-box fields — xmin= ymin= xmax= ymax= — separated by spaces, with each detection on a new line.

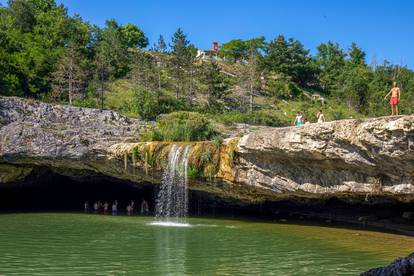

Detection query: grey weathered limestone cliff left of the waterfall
xmin=0 ymin=97 xmax=152 ymax=183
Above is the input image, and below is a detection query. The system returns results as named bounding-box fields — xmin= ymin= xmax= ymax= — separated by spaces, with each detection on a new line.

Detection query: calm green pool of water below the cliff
xmin=0 ymin=213 xmax=414 ymax=275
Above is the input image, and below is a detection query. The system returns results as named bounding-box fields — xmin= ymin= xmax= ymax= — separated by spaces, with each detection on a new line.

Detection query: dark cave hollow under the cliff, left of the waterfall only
xmin=0 ymin=168 xmax=155 ymax=212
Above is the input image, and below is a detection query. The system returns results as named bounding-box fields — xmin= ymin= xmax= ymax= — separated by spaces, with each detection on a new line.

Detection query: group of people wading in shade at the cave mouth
xmin=84 ymin=199 xmax=149 ymax=216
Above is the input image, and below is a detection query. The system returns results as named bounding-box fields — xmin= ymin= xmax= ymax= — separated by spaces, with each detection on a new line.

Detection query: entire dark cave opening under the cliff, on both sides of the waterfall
xmin=0 ymin=168 xmax=414 ymax=234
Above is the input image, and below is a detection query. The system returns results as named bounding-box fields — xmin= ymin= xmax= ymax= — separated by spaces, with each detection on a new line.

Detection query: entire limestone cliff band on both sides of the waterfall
xmin=0 ymin=97 xmax=414 ymax=201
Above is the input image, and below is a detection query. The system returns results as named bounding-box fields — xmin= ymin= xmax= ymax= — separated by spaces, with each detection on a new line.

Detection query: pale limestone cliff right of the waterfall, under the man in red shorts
xmin=236 ymin=116 xmax=414 ymax=199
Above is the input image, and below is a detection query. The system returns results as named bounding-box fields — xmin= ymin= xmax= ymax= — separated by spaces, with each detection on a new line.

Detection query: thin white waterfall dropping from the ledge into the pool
xmin=155 ymin=145 xmax=190 ymax=224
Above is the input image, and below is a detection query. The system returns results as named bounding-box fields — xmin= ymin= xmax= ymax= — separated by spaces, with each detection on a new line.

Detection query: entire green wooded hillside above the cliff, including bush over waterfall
xmin=0 ymin=0 xmax=414 ymax=129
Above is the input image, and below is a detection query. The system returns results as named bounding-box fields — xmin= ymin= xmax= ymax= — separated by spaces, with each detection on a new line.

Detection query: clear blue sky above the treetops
xmin=1 ymin=0 xmax=414 ymax=69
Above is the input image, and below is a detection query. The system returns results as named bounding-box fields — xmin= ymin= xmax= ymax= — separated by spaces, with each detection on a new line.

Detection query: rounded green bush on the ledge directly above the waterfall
xmin=142 ymin=111 xmax=218 ymax=142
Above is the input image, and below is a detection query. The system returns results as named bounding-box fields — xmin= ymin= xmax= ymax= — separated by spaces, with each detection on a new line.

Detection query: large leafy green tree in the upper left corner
xmin=0 ymin=0 xmax=68 ymax=97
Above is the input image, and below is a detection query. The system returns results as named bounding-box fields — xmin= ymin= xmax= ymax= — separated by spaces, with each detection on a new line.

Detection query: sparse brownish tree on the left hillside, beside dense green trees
xmin=53 ymin=45 xmax=85 ymax=105
